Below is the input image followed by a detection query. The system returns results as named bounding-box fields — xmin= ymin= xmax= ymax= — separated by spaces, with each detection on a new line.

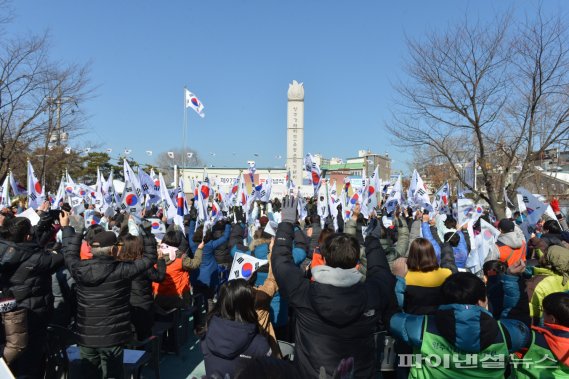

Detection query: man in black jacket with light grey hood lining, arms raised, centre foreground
xmin=271 ymin=198 xmax=395 ymax=378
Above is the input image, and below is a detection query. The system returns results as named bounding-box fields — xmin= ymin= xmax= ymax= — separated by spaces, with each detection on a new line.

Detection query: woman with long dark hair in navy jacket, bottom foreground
xmin=201 ymin=279 xmax=271 ymax=377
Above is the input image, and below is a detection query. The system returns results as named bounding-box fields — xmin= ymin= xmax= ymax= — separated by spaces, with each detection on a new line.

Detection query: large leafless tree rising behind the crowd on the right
xmin=388 ymin=12 xmax=569 ymax=217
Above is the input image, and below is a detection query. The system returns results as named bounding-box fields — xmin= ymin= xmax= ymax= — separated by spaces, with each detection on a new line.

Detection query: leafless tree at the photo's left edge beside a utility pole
xmin=0 ymin=2 xmax=89 ymax=185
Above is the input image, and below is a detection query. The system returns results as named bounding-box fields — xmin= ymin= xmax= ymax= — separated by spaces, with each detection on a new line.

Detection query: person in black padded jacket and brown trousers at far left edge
xmin=0 ymin=208 xmax=63 ymax=378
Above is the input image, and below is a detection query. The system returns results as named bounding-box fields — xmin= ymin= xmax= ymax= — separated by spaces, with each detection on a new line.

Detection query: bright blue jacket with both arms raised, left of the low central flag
xmin=188 ymin=221 xmax=231 ymax=288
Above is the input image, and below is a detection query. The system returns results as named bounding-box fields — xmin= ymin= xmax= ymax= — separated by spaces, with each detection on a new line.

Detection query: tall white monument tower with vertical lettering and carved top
xmin=286 ymin=80 xmax=304 ymax=187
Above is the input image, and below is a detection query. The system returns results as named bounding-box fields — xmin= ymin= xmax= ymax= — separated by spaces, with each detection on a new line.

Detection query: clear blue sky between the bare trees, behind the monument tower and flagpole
xmin=8 ymin=0 xmax=567 ymax=169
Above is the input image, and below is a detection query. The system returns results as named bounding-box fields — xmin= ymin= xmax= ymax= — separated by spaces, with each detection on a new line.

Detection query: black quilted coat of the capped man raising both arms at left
xmin=63 ymin=227 xmax=156 ymax=348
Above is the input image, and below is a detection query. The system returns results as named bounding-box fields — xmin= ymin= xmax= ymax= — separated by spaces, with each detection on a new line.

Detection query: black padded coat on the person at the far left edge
xmin=0 ymin=240 xmax=63 ymax=322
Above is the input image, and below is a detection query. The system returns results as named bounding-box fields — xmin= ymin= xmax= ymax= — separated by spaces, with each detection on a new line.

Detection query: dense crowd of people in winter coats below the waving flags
xmin=0 ymin=191 xmax=569 ymax=379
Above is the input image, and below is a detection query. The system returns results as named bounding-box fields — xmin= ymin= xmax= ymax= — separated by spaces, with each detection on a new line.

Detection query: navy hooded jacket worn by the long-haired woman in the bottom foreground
xmin=200 ymin=316 xmax=271 ymax=378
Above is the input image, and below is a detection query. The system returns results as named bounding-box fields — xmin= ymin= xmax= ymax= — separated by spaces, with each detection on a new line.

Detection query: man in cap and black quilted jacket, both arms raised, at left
xmin=60 ymin=213 xmax=156 ymax=378
